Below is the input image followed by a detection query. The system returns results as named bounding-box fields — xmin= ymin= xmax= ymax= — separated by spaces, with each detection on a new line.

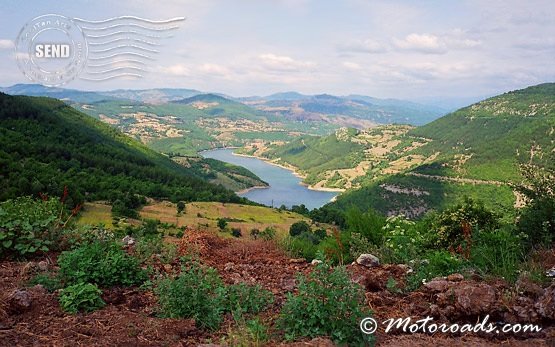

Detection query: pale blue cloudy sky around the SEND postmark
xmin=0 ymin=0 xmax=555 ymax=100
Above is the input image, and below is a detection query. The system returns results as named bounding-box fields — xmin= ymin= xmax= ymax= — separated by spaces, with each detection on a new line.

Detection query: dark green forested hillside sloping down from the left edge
xmin=0 ymin=93 xmax=251 ymax=207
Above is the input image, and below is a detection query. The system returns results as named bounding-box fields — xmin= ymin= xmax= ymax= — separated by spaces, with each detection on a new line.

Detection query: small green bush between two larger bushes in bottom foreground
xmin=226 ymin=283 xmax=274 ymax=314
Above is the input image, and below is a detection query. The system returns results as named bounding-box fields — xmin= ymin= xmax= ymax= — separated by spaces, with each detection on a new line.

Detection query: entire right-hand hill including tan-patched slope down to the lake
xmin=284 ymin=83 xmax=555 ymax=217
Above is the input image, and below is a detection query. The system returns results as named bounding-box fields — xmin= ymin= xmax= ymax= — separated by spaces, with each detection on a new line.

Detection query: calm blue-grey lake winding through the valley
xmin=200 ymin=148 xmax=338 ymax=210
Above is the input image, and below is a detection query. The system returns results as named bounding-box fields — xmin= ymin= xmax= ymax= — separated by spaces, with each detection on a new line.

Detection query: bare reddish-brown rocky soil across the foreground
xmin=0 ymin=233 xmax=555 ymax=347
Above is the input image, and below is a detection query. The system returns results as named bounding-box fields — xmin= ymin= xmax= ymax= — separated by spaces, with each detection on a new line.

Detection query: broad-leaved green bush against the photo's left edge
xmin=0 ymin=197 xmax=65 ymax=257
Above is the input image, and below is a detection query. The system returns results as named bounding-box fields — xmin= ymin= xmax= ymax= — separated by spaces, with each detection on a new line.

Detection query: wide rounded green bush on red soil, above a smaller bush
xmin=58 ymin=241 xmax=147 ymax=287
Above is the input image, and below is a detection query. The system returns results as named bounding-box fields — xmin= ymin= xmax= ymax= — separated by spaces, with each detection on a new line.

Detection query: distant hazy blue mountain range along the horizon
xmin=0 ymin=84 xmax=448 ymax=128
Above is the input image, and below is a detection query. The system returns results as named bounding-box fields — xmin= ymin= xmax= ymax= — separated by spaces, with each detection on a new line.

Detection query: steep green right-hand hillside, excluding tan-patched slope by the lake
xmin=324 ymin=83 xmax=555 ymax=216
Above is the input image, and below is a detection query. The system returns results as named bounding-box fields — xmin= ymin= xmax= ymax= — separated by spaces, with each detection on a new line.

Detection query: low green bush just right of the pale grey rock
xmin=407 ymin=251 xmax=464 ymax=290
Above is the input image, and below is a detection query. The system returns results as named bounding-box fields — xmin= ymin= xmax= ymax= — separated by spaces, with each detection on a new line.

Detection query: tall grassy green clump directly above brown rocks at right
xmin=470 ymin=229 xmax=524 ymax=282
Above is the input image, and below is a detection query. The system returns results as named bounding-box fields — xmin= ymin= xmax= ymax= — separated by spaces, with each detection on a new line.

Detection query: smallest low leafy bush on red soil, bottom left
xmin=58 ymin=283 xmax=106 ymax=314
